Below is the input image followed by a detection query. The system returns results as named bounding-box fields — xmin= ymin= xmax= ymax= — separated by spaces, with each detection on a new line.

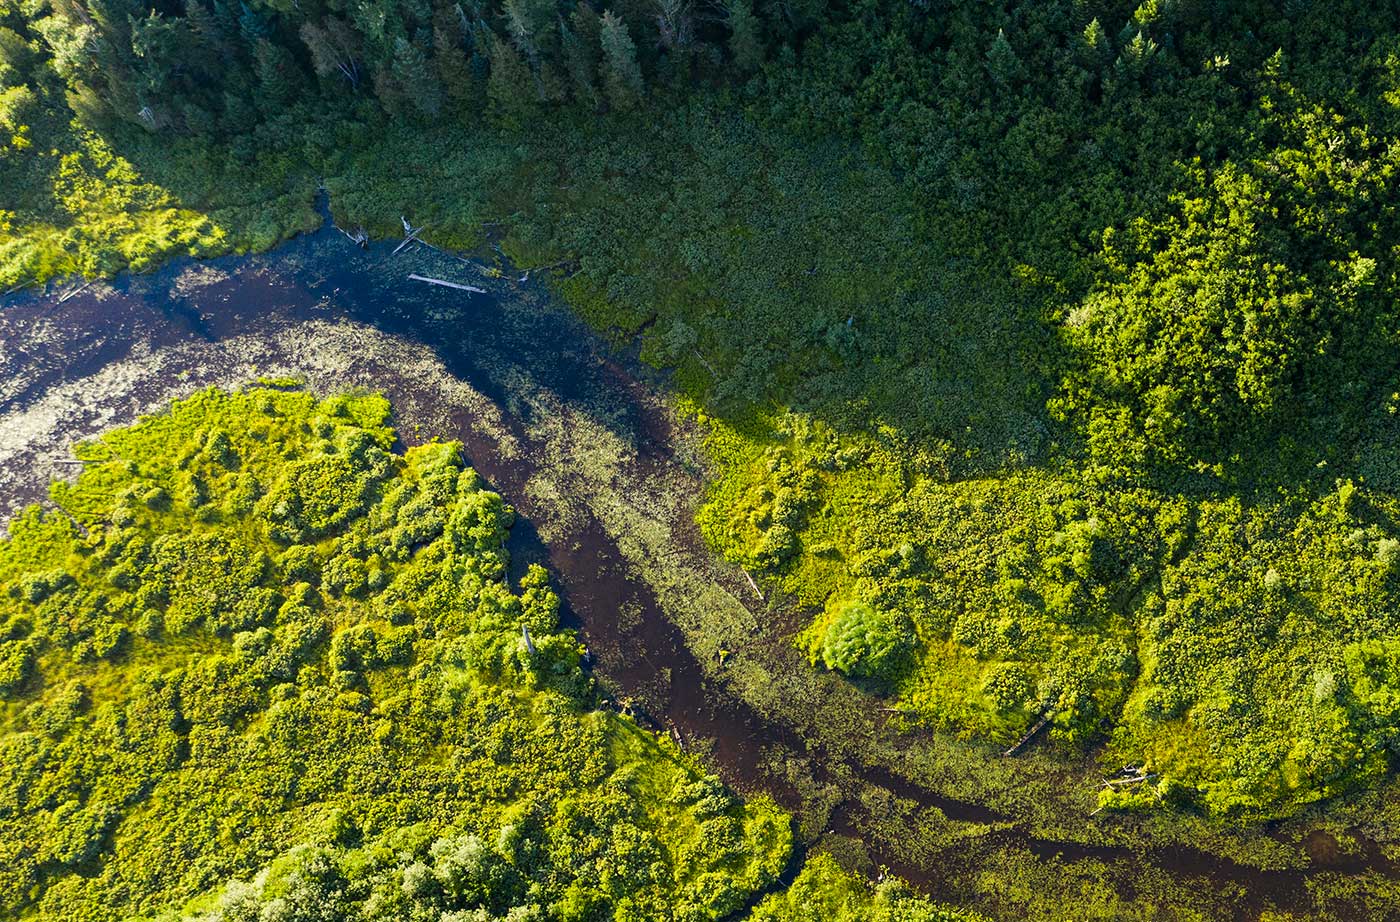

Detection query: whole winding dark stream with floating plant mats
xmin=0 ymin=228 xmax=1400 ymax=919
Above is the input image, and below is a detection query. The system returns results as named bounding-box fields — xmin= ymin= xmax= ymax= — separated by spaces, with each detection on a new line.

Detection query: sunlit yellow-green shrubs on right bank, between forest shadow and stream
xmin=700 ymin=402 xmax=1400 ymax=817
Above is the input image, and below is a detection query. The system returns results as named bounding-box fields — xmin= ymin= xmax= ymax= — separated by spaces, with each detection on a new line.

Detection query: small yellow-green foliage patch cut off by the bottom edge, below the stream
xmin=749 ymin=855 xmax=983 ymax=922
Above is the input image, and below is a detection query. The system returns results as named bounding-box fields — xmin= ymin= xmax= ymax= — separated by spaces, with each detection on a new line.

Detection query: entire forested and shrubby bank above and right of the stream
xmin=8 ymin=0 xmax=1400 ymax=816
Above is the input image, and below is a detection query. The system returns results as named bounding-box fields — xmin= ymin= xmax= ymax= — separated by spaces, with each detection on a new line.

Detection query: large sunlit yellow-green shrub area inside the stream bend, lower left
xmin=0 ymin=388 xmax=792 ymax=922
